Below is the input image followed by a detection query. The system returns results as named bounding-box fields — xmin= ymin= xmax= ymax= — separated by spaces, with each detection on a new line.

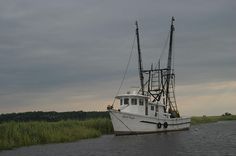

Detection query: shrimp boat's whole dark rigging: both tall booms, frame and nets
xmin=136 ymin=17 xmax=179 ymax=117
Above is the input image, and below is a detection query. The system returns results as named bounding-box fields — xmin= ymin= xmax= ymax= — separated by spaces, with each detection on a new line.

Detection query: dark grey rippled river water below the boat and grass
xmin=0 ymin=121 xmax=236 ymax=156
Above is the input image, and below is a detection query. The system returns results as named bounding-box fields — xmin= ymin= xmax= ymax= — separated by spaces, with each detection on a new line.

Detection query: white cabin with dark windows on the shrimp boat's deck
xmin=116 ymin=92 xmax=170 ymax=118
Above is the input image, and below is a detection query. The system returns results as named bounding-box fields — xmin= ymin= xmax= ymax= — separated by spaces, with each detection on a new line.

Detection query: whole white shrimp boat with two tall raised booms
xmin=107 ymin=17 xmax=191 ymax=135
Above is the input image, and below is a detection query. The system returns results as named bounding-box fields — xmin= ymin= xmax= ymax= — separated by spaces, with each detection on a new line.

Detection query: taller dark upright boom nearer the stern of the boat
xmin=166 ymin=17 xmax=175 ymax=108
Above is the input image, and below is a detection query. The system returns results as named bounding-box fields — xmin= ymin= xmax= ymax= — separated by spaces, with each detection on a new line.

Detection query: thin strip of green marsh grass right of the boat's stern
xmin=191 ymin=115 xmax=236 ymax=125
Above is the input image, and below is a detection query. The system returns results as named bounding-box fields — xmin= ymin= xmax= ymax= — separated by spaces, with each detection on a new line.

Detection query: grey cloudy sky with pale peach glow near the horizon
xmin=0 ymin=0 xmax=236 ymax=115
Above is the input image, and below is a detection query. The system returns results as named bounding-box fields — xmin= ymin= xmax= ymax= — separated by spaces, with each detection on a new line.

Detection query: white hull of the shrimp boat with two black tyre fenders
xmin=109 ymin=110 xmax=191 ymax=135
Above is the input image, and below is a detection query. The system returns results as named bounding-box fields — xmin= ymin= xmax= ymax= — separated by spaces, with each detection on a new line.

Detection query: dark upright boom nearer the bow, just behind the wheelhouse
xmin=135 ymin=21 xmax=144 ymax=95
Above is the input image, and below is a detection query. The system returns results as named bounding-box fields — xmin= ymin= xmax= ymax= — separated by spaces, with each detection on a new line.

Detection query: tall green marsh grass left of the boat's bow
xmin=0 ymin=118 xmax=113 ymax=150
